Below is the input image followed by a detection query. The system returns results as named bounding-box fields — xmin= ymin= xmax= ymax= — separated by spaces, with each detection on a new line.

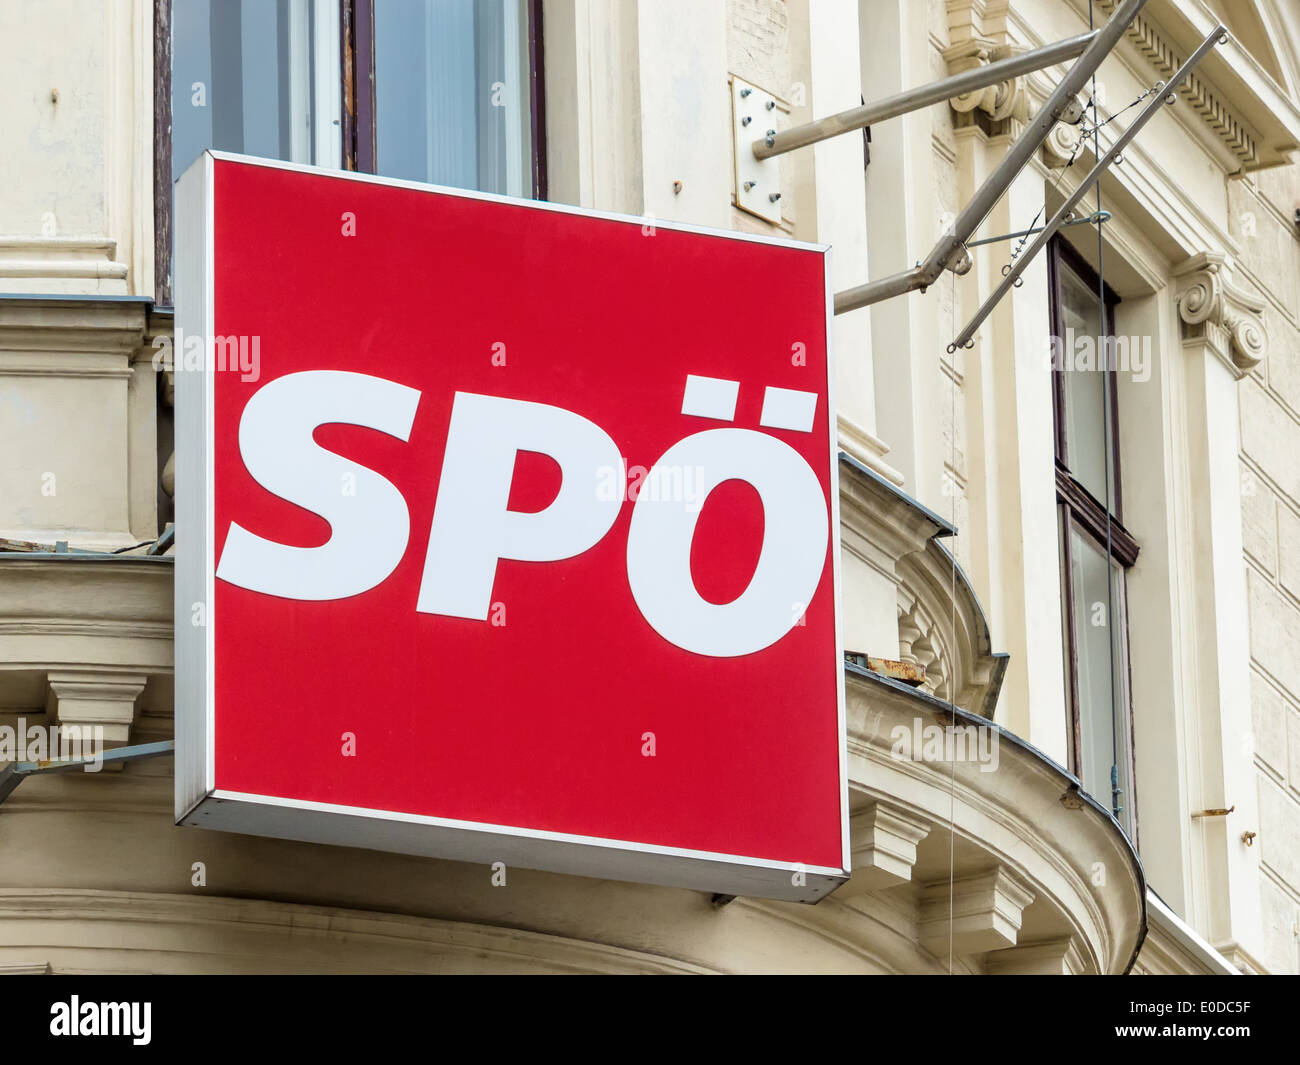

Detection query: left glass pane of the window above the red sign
xmin=172 ymin=0 xmax=342 ymax=181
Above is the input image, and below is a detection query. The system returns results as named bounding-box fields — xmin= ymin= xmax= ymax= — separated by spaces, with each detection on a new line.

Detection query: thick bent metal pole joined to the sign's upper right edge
xmin=835 ymin=0 xmax=1147 ymax=315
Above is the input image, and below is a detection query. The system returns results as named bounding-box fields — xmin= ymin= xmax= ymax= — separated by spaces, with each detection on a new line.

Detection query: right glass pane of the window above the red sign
xmin=374 ymin=0 xmax=533 ymax=196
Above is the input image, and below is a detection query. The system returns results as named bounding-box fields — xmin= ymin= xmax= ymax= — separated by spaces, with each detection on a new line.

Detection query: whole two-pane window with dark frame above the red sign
xmin=155 ymin=0 xmax=546 ymax=304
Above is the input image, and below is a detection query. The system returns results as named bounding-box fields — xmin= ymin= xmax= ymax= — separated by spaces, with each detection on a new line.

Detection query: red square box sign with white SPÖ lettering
xmin=173 ymin=153 xmax=849 ymax=901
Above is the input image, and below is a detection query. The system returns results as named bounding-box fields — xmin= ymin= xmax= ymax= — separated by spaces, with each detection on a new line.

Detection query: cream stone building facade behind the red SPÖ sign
xmin=0 ymin=0 xmax=1300 ymax=974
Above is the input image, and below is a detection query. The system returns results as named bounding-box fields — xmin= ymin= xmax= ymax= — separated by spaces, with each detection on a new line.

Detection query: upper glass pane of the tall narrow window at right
xmin=1061 ymin=263 xmax=1114 ymax=503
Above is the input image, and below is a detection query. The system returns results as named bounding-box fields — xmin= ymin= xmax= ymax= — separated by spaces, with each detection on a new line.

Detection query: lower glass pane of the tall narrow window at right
xmin=1070 ymin=529 xmax=1130 ymax=808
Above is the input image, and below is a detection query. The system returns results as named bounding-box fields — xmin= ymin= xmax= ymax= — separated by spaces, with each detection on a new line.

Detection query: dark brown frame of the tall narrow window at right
xmin=1047 ymin=237 xmax=1140 ymax=840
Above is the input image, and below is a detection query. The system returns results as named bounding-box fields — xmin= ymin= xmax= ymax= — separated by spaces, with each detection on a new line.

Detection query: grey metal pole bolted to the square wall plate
xmin=753 ymin=30 xmax=1097 ymax=159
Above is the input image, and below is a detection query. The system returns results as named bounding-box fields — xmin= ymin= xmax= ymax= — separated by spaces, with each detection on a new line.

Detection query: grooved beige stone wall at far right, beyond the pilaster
xmin=1229 ymin=166 xmax=1300 ymax=973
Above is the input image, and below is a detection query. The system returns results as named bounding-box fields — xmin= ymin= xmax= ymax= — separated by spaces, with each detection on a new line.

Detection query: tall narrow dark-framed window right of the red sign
xmin=1048 ymin=239 xmax=1139 ymax=832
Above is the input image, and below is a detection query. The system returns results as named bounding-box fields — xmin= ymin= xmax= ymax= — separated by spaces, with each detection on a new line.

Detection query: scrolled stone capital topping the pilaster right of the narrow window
xmin=1174 ymin=251 xmax=1269 ymax=380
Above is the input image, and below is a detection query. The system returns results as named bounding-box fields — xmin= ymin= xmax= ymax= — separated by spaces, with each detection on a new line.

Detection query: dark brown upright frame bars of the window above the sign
xmin=153 ymin=0 xmax=547 ymax=307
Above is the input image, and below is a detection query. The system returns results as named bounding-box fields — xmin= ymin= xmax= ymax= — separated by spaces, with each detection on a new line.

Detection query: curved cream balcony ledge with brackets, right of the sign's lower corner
xmin=847 ymin=664 xmax=1147 ymax=974
